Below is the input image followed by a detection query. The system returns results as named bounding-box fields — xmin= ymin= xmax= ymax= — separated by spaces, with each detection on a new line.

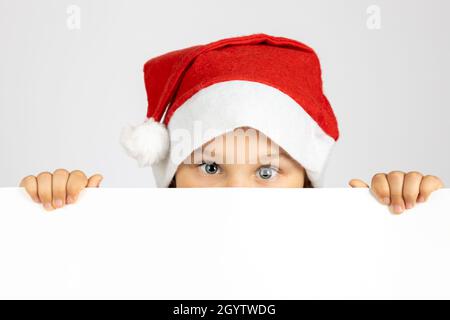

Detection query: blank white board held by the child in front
xmin=0 ymin=188 xmax=450 ymax=299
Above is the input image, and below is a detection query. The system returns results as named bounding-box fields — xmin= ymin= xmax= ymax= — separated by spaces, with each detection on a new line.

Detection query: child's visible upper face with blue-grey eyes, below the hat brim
xmin=175 ymin=127 xmax=306 ymax=188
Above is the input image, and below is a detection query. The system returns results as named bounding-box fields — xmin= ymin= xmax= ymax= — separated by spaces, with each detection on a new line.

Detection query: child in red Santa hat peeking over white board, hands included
xmin=20 ymin=34 xmax=443 ymax=213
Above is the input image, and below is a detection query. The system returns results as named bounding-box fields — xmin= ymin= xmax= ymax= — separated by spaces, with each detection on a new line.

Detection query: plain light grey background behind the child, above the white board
xmin=0 ymin=0 xmax=450 ymax=187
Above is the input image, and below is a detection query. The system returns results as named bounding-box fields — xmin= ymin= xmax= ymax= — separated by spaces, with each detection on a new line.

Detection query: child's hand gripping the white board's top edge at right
xmin=348 ymin=171 xmax=444 ymax=213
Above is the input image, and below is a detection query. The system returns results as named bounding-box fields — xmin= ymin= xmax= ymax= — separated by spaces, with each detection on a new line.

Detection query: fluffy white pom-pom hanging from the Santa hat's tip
xmin=120 ymin=118 xmax=169 ymax=167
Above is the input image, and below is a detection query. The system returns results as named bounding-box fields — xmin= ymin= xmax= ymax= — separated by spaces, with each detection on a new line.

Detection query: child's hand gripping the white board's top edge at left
xmin=20 ymin=169 xmax=103 ymax=211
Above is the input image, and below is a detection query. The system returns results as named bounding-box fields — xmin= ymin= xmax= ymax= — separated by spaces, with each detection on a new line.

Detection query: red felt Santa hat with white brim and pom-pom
xmin=121 ymin=34 xmax=339 ymax=187
